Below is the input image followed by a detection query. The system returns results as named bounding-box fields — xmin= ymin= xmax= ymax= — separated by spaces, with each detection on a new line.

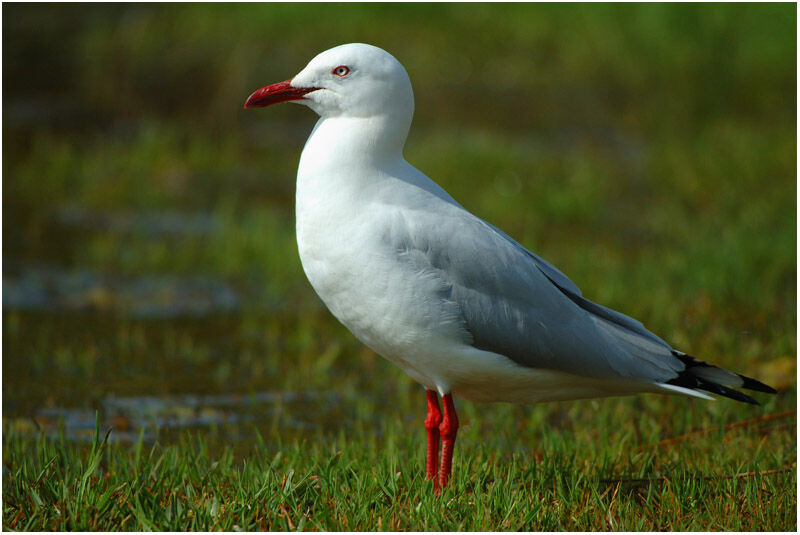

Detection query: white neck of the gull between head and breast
xmin=298 ymin=116 xmax=411 ymax=174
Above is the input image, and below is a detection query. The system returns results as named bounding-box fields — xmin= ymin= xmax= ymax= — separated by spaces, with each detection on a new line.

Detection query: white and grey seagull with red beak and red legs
xmin=244 ymin=43 xmax=776 ymax=492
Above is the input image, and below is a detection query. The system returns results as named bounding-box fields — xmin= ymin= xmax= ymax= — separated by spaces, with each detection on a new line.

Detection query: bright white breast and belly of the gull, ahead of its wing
xmin=297 ymin=165 xmax=470 ymax=388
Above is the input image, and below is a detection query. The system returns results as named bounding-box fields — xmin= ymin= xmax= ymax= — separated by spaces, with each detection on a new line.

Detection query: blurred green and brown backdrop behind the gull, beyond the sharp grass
xmin=2 ymin=4 xmax=797 ymax=447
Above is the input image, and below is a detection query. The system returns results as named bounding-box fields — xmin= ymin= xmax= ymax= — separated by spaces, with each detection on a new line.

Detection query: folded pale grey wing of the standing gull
xmin=393 ymin=207 xmax=684 ymax=382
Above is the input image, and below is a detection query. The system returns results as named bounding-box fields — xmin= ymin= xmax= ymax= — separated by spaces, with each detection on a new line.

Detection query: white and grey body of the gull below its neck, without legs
xmin=296 ymin=134 xmax=682 ymax=402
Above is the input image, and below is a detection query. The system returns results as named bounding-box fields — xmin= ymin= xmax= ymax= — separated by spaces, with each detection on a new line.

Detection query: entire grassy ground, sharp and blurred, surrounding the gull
xmin=2 ymin=4 xmax=797 ymax=531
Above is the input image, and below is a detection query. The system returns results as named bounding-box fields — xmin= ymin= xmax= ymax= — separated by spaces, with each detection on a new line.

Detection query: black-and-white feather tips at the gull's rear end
xmin=666 ymin=351 xmax=777 ymax=405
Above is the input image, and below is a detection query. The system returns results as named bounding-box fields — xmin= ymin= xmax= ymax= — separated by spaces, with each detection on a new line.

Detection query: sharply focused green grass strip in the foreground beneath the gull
xmin=3 ymin=406 xmax=797 ymax=531
